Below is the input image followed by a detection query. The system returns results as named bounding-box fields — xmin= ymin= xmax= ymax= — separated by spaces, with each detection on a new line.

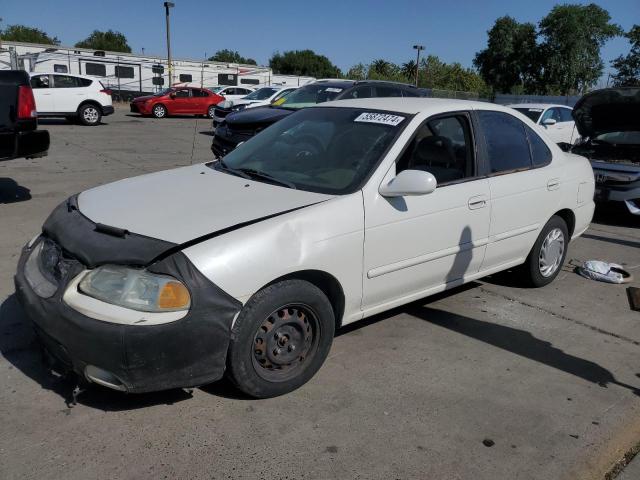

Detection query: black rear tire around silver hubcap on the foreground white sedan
xmin=520 ymin=215 xmax=570 ymax=288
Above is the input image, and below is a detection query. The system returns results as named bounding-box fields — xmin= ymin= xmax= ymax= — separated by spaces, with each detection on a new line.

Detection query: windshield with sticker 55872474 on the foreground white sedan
xmin=208 ymin=107 xmax=409 ymax=195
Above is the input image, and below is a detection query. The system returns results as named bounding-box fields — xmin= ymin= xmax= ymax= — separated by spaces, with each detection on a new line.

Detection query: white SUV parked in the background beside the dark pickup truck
xmin=31 ymin=73 xmax=113 ymax=125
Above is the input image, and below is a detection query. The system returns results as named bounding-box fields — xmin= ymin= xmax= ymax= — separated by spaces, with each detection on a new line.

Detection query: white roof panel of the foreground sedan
xmin=320 ymin=97 xmax=521 ymax=116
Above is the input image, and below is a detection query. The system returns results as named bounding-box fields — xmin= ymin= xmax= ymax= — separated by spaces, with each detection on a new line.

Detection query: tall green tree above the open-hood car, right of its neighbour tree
xmin=539 ymin=3 xmax=622 ymax=95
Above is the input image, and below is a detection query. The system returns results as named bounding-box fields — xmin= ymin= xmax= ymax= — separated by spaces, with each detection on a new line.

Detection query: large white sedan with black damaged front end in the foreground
xmin=16 ymin=98 xmax=594 ymax=397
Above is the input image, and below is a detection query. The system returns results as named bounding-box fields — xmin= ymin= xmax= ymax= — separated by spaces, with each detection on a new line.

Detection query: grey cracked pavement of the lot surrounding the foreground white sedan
xmin=0 ymin=109 xmax=640 ymax=480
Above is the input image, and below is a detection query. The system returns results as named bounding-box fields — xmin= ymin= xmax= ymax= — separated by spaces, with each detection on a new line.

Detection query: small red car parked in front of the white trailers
xmin=131 ymin=87 xmax=224 ymax=118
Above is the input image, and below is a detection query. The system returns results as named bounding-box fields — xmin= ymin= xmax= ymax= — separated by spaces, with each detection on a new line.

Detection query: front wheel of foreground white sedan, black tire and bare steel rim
xmin=227 ymin=280 xmax=335 ymax=398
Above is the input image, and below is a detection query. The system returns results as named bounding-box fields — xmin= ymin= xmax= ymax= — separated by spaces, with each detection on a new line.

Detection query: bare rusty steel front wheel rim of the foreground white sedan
xmin=251 ymin=304 xmax=320 ymax=382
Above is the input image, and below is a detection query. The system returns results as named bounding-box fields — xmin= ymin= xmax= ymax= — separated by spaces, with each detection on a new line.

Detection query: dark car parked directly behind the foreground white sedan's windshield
xmin=211 ymin=80 xmax=424 ymax=158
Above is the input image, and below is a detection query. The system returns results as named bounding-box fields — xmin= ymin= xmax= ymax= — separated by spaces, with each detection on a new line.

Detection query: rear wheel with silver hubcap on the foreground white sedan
xmin=522 ymin=215 xmax=569 ymax=287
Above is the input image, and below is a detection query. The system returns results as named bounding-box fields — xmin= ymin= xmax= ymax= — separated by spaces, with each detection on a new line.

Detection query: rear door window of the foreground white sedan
xmin=477 ymin=111 xmax=531 ymax=175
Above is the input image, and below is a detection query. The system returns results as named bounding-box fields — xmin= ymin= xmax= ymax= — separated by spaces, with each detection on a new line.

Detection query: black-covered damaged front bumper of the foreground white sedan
xmin=15 ymin=198 xmax=241 ymax=392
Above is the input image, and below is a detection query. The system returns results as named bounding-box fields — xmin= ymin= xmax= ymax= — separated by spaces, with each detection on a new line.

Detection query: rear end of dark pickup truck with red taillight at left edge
xmin=0 ymin=70 xmax=49 ymax=161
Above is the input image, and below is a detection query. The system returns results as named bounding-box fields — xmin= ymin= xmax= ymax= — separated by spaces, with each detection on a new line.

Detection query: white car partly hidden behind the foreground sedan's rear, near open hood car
xmin=509 ymin=103 xmax=579 ymax=145
